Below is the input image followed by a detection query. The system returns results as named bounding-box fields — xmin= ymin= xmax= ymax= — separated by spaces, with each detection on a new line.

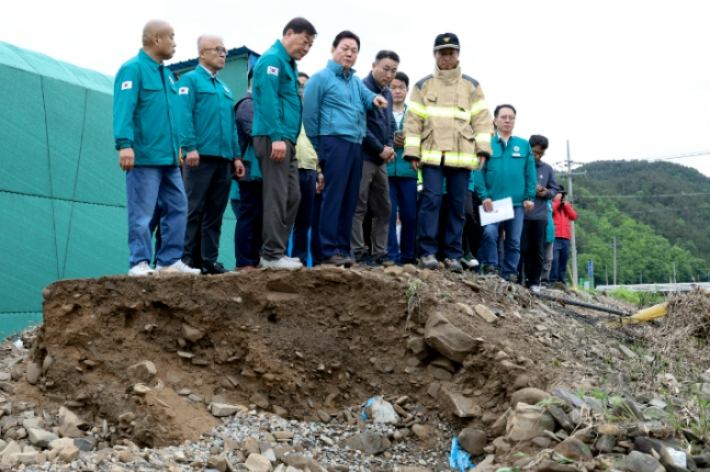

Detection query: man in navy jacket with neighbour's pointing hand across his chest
xmin=350 ymin=51 xmax=399 ymax=267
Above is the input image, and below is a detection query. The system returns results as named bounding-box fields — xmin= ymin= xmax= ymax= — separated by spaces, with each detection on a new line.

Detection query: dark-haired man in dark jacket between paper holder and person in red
xmin=518 ymin=134 xmax=559 ymax=292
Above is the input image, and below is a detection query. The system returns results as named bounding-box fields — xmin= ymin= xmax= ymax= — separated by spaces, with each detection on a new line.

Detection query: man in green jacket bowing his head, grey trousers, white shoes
xmin=252 ymin=18 xmax=317 ymax=269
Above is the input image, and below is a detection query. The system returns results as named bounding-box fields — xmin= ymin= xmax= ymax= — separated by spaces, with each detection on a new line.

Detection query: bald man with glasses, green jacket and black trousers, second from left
xmin=178 ymin=36 xmax=244 ymax=274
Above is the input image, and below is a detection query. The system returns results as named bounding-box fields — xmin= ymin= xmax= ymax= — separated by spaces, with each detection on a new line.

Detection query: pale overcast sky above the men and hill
xmin=0 ymin=0 xmax=710 ymax=175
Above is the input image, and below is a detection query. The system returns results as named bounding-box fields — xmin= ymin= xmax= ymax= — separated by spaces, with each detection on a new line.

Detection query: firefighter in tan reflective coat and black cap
xmin=404 ymin=33 xmax=494 ymax=272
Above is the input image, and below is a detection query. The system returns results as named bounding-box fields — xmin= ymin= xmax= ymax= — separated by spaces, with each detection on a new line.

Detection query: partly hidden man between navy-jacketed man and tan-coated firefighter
xmin=387 ymin=72 xmax=417 ymax=265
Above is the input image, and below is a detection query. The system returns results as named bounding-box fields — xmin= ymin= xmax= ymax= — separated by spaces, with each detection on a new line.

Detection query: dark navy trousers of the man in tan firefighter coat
xmin=417 ymin=165 xmax=471 ymax=260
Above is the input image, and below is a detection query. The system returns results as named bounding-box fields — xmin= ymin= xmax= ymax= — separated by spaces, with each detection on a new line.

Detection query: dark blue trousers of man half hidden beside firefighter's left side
xmin=387 ymin=177 xmax=417 ymax=264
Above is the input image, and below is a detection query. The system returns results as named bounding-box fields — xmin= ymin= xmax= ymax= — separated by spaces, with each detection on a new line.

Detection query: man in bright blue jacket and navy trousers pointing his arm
xmin=303 ymin=31 xmax=387 ymax=267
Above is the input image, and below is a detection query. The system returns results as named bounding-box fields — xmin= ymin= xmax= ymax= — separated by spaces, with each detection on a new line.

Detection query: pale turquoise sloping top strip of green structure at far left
xmin=0 ymin=42 xmax=113 ymax=94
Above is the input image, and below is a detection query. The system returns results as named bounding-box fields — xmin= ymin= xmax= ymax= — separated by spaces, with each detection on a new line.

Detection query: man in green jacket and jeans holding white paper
xmin=475 ymin=105 xmax=537 ymax=282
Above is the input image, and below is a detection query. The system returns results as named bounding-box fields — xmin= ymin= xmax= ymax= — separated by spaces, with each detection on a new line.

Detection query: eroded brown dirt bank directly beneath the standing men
xmin=25 ymin=268 xmax=563 ymax=446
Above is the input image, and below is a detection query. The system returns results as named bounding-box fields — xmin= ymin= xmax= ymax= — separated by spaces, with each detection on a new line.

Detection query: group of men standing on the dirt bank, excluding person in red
xmin=114 ymin=18 xmax=580 ymax=286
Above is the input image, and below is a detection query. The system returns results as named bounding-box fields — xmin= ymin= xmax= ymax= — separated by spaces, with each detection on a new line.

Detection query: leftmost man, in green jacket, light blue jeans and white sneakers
xmin=113 ymin=20 xmax=200 ymax=276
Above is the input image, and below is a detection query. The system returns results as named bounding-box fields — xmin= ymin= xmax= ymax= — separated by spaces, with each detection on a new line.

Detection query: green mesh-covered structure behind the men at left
xmin=0 ymin=42 xmax=247 ymax=337
